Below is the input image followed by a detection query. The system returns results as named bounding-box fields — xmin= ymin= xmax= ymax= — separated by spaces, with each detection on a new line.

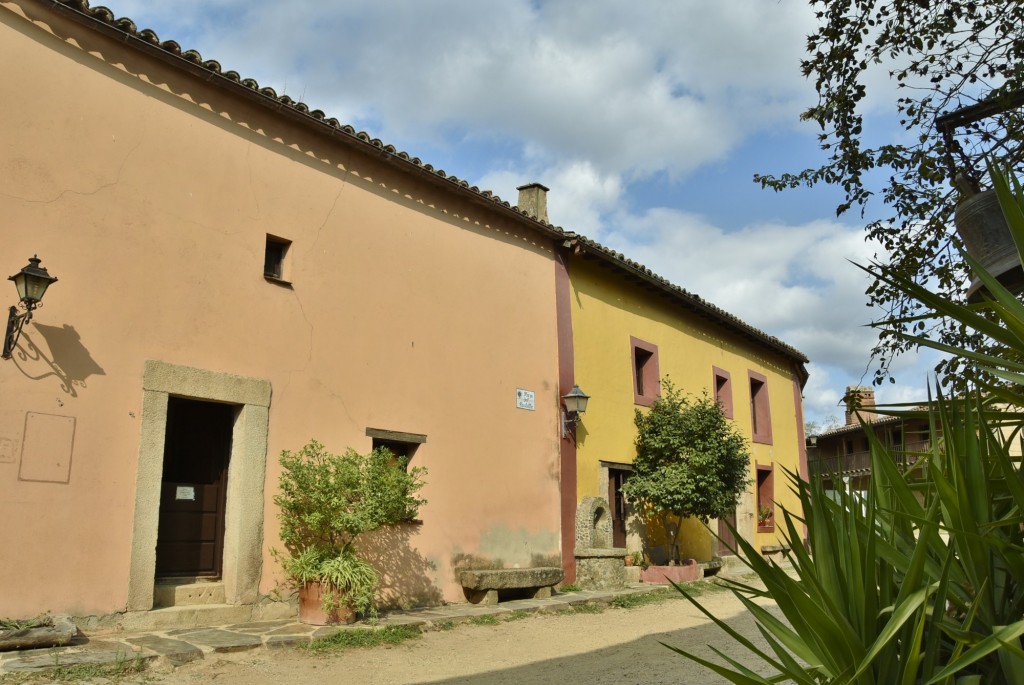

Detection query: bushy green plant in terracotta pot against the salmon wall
xmin=272 ymin=440 xmax=426 ymax=624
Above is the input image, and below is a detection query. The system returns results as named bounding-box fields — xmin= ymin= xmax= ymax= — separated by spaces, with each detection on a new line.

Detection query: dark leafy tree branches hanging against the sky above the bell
xmin=755 ymin=0 xmax=1024 ymax=384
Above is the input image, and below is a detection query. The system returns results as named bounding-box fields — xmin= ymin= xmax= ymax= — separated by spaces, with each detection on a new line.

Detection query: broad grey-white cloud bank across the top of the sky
xmin=105 ymin=0 xmax=811 ymax=180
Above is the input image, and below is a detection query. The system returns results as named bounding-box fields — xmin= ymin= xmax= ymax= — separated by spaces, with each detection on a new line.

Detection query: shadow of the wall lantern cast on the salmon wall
xmin=15 ymin=323 xmax=105 ymax=397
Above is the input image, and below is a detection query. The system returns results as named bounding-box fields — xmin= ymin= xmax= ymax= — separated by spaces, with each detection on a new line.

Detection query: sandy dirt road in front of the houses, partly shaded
xmin=147 ymin=591 xmax=774 ymax=685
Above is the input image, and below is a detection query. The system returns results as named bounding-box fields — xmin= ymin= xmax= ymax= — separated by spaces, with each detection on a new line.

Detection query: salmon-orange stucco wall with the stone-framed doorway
xmin=0 ymin=2 xmax=559 ymax=616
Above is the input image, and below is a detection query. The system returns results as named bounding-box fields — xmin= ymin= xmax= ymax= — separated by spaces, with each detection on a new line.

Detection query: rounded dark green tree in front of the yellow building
xmin=623 ymin=379 xmax=751 ymax=561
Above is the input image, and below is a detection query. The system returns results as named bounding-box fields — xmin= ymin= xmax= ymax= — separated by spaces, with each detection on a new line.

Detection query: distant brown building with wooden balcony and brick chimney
xmin=807 ymin=386 xmax=931 ymax=489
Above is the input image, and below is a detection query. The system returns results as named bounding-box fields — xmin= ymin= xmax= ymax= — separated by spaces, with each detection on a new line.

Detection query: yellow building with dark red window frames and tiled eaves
xmin=559 ymin=236 xmax=807 ymax=560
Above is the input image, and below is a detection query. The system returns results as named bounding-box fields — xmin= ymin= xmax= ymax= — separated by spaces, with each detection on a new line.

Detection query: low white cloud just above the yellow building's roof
xmin=604 ymin=209 xmax=874 ymax=368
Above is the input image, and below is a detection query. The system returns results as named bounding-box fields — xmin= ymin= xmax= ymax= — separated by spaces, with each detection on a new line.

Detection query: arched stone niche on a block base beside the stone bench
xmin=575 ymin=497 xmax=626 ymax=590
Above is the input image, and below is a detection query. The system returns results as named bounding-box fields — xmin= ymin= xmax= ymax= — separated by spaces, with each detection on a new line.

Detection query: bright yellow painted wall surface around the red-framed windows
xmin=569 ymin=257 xmax=803 ymax=559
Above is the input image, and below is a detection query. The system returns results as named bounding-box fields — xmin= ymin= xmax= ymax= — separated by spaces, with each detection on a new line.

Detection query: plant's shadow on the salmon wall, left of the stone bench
xmin=357 ymin=523 xmax=443 ymax=608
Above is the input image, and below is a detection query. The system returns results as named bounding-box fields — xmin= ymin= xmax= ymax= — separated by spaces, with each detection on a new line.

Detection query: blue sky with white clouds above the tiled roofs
xmin=108 ymin=0 xmax=934 ymax=424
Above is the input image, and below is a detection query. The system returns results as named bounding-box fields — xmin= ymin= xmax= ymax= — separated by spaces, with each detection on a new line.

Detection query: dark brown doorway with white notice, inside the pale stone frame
xmin=157 ymin=397 xmax=237 ymax=577
